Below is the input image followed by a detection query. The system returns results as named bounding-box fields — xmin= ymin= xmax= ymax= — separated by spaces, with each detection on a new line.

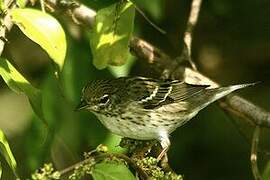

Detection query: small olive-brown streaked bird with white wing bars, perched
xmin=76 ymin=77 xmax=254 ymax=160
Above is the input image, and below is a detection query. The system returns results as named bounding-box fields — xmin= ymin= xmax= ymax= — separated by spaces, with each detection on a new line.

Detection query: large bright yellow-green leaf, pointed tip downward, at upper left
xmin=11 ymin=8 xmax=67 ymax=70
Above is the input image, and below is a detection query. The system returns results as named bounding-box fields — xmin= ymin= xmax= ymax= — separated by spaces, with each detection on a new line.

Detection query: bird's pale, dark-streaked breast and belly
xmin=92 ymin=102 xmax=197 ymax=140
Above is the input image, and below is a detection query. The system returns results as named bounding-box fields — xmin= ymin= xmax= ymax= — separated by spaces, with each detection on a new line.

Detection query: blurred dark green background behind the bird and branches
xmin=0 ymin=0 xmax=270 ymax=180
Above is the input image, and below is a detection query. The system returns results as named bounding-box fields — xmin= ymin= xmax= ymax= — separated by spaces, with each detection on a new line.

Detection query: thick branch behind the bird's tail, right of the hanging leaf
xmin=130 ymin=38 xmax=270 ymax=128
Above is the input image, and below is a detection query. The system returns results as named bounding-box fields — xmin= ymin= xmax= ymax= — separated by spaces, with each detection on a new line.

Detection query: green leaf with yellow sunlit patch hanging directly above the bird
xmin=90 ymin=1 xmax=135 ymax=69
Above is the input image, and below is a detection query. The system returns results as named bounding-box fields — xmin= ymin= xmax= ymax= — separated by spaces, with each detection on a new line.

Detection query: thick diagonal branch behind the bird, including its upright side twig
xmin=40 ymin=0 xmax=270 ymax=128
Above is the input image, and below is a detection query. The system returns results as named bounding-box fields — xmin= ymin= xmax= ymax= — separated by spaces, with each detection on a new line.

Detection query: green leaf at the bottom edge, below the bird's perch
xmin=92 ymin=162 xmax=135 ymax=180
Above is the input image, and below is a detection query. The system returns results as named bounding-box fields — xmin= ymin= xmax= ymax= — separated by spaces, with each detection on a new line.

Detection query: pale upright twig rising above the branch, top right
xmin=184 ymin=0 xmax=202 ymax=70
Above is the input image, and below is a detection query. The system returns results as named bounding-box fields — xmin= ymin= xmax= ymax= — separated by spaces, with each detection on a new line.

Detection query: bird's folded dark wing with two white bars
xmin=127 ymin=78 xmax=209 ymax=109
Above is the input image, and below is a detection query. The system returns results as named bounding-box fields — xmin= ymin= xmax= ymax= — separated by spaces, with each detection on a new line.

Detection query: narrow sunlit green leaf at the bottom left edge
xmin=0 ymin=130 xmax=17 ymax=176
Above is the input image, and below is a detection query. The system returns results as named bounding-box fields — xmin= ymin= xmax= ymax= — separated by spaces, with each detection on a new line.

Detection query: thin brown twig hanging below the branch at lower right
xmin=250 ymin=126 xmax=261 ymax=180
